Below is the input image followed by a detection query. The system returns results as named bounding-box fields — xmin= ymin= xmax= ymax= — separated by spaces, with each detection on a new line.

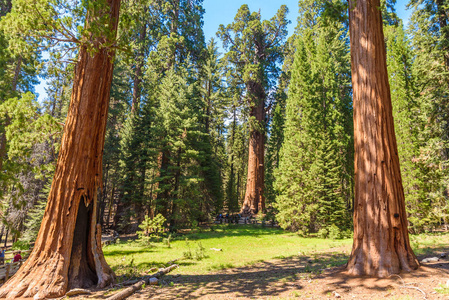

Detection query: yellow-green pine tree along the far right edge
xmin=408 ymin=0 xmax=449 ymax=231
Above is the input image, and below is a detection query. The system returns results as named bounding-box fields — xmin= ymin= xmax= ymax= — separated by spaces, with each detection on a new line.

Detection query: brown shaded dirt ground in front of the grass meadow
xmin=79 ymin=251 xmax=449 ymax=300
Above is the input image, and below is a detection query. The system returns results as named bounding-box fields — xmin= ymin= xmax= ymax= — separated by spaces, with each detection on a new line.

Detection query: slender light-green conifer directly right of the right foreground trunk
xmin=385 ymin=24 xmax=442 ymax=232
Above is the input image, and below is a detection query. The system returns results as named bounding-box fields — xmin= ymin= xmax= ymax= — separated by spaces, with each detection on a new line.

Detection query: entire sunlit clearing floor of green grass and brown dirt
xmin=78 ymin=226 xmax=449 ymax=300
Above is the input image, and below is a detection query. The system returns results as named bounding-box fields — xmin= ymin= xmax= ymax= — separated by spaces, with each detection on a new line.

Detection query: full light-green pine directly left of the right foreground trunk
xmin=275 ymin=1 xmax=352 ymax=233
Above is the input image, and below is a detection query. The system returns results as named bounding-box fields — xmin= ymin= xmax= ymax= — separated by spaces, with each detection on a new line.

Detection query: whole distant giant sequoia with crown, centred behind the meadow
xmin=217 ymin=4 xmax=288 ymax=214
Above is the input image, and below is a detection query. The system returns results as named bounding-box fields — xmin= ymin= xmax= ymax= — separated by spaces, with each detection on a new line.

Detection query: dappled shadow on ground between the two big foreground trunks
xmin=130 ymin=253 xmax=347 ymax=299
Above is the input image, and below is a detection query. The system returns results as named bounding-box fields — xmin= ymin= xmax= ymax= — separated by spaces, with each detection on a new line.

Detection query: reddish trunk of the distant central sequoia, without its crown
xmin=241 ymin=82 xmax=265 ymax=215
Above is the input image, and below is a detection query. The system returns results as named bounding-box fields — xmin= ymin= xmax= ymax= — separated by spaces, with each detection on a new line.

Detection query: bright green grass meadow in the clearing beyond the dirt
xmin=103 ymin=225 xmax=449 ymax=278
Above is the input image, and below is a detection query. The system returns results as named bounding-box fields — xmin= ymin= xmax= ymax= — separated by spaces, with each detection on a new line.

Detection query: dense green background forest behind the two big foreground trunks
xmin=0 ymin=0 xmax=449 ymax=260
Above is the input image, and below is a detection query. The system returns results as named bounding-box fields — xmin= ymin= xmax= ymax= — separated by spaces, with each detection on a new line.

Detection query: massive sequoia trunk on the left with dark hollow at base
xmin=0 ymin=0 xmax=120 ymax=299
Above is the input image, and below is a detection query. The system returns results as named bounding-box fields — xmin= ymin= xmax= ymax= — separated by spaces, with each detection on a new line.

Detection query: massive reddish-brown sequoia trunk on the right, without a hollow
xmin=347 ymin=0 xmax=419 ymax=277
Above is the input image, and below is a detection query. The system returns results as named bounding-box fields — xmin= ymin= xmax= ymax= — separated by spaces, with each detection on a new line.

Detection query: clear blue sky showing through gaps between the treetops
xmin=36 ymin=0 xmax=410 ymax=101
